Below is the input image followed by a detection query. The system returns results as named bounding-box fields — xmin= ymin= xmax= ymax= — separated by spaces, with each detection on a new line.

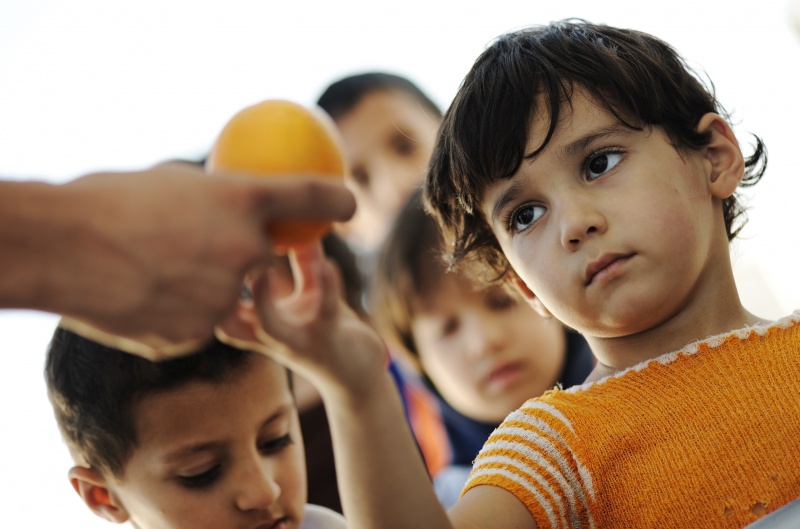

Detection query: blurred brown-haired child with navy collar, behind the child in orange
xmin=372 ymin=191 xmax=594 ymax=507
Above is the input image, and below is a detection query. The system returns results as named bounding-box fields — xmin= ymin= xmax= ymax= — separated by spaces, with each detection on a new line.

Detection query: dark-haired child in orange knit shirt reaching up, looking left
xmin=231 ymin=21 xmax=800 ymax=529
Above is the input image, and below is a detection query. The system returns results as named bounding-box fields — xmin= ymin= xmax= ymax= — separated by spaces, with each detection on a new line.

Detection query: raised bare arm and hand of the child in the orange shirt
xmin=221 ymin=243 xmax=536 ymax=529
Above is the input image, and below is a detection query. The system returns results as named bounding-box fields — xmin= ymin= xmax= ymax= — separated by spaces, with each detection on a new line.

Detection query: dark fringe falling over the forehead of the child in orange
xmin=444 ymin=32 xmax=652 ymax=213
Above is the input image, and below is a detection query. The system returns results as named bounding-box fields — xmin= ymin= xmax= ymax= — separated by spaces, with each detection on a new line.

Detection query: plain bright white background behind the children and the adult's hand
xmin=0 ymin=0 xmax=800 ymax=528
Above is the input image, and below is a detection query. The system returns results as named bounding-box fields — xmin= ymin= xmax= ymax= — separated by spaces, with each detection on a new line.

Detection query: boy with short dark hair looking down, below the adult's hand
xmin=46 ymin=329 xmax=345 ymax=529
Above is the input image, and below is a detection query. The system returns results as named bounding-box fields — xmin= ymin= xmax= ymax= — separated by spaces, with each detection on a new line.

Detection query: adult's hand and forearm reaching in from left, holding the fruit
xmin=0 ymin=163 xmax=355 ymax=359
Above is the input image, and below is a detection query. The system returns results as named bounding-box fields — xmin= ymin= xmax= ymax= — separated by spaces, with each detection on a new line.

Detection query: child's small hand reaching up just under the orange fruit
xmin=218 ymin=243 xmax=386 ymax=393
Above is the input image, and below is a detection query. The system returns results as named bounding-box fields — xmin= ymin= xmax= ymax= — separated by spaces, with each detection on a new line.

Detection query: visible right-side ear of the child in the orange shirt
xmin=697 ymin=112 xmax=744 ymax=200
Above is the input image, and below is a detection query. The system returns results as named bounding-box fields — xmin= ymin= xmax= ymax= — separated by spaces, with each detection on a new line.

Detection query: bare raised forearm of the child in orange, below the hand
xmin=323 ymin=373 xmax=452 ymax=529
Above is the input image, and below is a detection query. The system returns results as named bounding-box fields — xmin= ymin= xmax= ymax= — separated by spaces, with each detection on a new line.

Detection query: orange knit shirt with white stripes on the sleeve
xmin=462 ymin=311 xmax=800 ymax=529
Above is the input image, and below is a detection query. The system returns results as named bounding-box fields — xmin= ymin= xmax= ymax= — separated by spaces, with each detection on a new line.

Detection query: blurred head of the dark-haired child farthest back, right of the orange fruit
xmin=317 ymin=72 xmax=442 ymax=253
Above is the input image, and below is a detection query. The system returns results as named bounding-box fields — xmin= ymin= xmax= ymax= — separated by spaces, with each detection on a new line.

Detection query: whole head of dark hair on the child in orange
xmin=424 ymin=19 xmax=767 ymax=281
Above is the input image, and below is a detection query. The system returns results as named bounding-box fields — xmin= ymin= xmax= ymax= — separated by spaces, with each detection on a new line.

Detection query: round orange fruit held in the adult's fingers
xmin=206 ymin=99 xmax=346 ymax=249
